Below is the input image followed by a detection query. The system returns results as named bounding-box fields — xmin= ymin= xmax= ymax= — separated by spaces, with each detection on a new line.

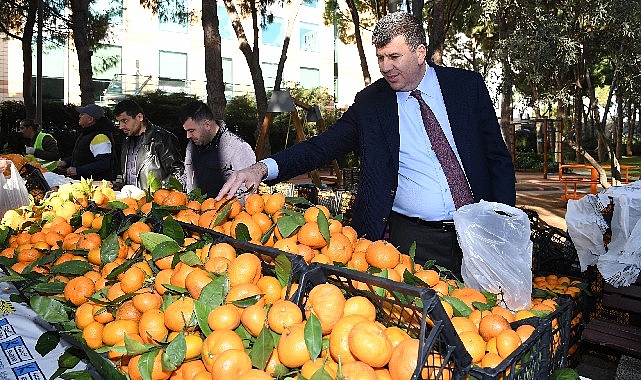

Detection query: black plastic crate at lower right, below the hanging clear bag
xmin=469 ymin=318 xmax=552 ymax=380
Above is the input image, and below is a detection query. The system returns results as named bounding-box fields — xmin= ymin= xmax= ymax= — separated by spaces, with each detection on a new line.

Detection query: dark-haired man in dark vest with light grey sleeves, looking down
xmin=180 ymin=101 xmax=256 ymax=197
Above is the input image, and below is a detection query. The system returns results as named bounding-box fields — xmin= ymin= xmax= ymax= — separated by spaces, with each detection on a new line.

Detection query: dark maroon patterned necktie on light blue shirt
xmin=410 ymin=90 xmax=474 ymax=209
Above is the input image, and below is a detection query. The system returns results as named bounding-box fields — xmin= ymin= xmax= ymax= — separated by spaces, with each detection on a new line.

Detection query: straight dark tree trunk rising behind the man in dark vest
xmin=202 ymin=0 xmax=227 ymax=120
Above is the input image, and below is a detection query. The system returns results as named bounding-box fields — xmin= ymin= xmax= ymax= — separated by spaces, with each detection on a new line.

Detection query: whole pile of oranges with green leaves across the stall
xmin=0 ymin=183 xmax=568 ymax=379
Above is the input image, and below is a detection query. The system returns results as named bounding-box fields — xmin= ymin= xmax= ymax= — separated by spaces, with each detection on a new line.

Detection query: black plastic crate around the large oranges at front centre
xmin=292 ymin=263 xmax=472 ymax=380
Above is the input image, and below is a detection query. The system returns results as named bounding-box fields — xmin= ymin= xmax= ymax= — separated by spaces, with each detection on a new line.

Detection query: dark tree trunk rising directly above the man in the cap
xmin=71 ymin=0 xmax=95 ymax=105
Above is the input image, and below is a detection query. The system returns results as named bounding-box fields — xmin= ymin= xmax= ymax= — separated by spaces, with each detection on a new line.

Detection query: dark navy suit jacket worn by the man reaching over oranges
xmin=272 ymin=66 xmax=516 ymax=240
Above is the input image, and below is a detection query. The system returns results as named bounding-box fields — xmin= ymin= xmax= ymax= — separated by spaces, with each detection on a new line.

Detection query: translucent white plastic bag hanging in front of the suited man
xmin=454 ymin=200 xmax=532 ymax=310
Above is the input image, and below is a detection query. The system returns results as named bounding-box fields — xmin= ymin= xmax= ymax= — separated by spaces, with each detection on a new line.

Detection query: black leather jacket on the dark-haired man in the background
xmin=120 ymin=121 xmax=185 ymax=190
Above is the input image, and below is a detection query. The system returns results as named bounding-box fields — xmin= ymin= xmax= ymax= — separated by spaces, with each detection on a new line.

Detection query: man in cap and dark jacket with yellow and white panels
xmin=58 ymin=104 xmax=117 ymax=181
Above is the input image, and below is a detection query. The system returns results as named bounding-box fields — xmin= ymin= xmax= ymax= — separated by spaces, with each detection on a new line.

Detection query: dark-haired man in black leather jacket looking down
xmin=114 ymin=99 xmax=184 ymax=189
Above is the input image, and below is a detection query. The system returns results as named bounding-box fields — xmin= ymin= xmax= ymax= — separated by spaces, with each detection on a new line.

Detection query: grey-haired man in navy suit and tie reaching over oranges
xmin=218 ymin=12 xmax=516 ymax=274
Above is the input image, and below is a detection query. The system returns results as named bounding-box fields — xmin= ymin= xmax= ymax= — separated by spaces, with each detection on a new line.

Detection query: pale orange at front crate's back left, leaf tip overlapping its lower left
xmin=305 ymin=284 xmax=345 ymax=335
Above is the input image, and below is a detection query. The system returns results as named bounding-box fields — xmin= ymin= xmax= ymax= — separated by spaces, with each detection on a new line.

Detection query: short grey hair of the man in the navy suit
xmin=372 ymin=12 xmax=427 ymax=51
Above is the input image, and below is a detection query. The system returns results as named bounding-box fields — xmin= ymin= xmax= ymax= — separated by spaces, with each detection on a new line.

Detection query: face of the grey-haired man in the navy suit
xmin=376 ymin=36 xmax=427 ymax=91
